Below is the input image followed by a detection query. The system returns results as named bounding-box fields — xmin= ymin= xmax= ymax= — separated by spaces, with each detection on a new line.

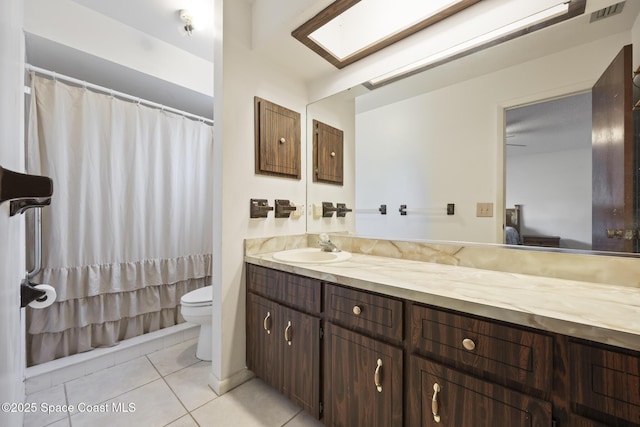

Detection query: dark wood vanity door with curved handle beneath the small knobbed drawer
xmin=324 ymin=323 xmax=403 ymax=427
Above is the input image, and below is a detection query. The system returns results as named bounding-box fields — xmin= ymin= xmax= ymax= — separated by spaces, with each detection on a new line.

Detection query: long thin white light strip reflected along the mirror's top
xmin=369 ymin=3 xmax=569 ymax=86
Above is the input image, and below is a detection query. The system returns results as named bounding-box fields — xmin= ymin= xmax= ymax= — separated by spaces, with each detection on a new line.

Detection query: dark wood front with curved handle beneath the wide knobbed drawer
xmin=408 ymin=356 xmax=552 ymax=427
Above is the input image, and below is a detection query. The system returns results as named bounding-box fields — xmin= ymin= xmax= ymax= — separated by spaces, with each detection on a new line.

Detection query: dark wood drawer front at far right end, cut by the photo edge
xmin=569 ymin=343 xmax=640 ymax=425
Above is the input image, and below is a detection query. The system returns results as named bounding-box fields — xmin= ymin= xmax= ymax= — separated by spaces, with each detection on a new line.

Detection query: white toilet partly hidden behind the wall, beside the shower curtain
xmin=180 ymin=286 xmax=213 ymax=361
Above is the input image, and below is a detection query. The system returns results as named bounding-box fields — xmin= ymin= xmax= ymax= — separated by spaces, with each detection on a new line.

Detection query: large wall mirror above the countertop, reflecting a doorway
xmin=307 ymin=1 xmax=640 ymax=253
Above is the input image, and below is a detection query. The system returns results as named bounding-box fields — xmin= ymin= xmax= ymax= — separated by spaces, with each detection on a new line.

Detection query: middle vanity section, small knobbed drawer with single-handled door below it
xmin=324 ymin=284 xmax=404 ymax=427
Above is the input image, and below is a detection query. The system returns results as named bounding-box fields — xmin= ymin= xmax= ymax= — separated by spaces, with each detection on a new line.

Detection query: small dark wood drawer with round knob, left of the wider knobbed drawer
xmin=325 ymin=284 xmax=402 ymax=341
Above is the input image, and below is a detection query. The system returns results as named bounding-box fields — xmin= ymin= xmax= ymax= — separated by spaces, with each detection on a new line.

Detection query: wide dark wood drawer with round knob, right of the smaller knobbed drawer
xmin=411 ymin=305 xmax=553 ymax=391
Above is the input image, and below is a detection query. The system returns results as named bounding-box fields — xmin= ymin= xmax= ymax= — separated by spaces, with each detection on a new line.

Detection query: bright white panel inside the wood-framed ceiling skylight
xmin=309 ymin=0 xmax=464 ymax=61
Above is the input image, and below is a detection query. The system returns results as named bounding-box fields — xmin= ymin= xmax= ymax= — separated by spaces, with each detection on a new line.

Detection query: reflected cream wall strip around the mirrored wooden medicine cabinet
xmin=307 ymin=96 xmax=355 ymax=233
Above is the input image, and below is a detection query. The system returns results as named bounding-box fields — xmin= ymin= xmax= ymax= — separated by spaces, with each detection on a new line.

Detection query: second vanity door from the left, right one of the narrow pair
xmin=280 ymin=307 xmax=320 ymax=418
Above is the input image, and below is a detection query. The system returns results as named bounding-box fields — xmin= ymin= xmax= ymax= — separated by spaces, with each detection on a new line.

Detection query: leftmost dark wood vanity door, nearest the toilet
xmin=247 ymin=293 xmax=282 ymax=391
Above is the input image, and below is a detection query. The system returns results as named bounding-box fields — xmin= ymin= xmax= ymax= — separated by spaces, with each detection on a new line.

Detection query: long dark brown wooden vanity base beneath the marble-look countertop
xmin=246 ymin=263 xmax=640 ymax=427
